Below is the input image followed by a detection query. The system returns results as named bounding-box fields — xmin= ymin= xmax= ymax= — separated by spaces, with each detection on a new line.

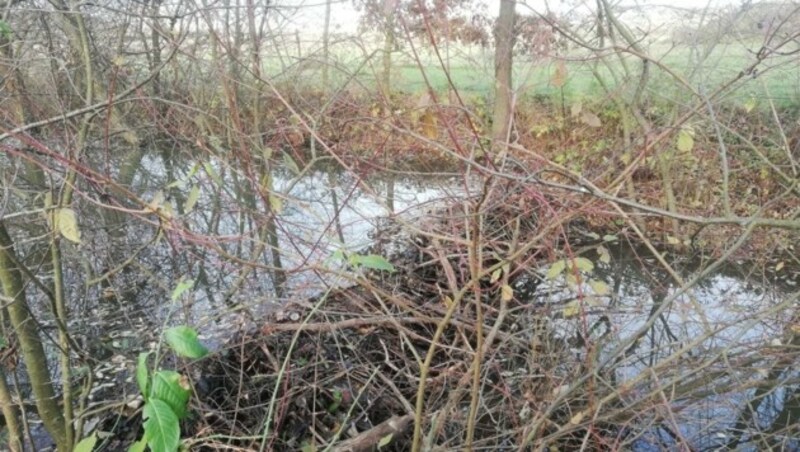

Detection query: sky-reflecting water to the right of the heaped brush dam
xmin=535 ymin=246 xmax=800 ymax=451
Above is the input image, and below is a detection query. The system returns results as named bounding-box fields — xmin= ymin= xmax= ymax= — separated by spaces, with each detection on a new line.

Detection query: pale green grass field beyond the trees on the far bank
xmin=260 ymin=38 xmax=800 ymax=109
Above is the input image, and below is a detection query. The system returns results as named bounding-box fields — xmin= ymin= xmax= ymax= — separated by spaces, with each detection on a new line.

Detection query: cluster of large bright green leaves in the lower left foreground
xmin=135 ymin=324 xmax=208 ymax=452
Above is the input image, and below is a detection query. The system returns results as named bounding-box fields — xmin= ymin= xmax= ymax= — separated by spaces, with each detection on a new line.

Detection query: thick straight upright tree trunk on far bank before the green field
xmin=492 ymin=0 xmax=516 ymax=154
